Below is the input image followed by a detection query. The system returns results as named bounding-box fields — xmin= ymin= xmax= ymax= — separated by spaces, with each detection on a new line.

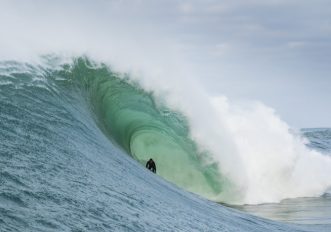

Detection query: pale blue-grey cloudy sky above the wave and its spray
xmin=0 ymin=0 xmax=331 ymax=128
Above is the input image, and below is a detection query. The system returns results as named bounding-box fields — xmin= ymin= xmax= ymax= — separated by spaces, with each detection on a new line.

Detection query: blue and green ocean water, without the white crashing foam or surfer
xmin=0 ymin=57 xmax=331 ymax=231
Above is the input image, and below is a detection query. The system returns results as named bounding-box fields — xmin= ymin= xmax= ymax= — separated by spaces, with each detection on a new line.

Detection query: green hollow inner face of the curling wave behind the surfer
xmin=57 ymin=58 xmax=226 ymax=199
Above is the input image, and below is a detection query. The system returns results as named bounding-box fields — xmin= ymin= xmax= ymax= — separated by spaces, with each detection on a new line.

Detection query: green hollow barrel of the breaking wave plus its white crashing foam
xmin=24 ymin=57 xmax=331 ymax=204
